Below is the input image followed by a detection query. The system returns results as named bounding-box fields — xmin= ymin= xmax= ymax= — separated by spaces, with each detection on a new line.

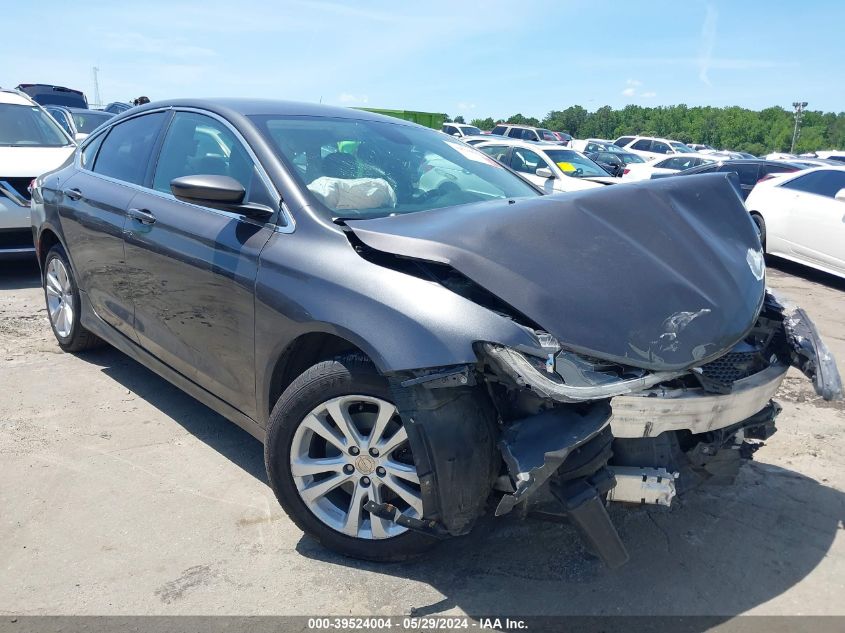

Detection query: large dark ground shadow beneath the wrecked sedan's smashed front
xmin=297 ymin=462 xmax=845 ymax=630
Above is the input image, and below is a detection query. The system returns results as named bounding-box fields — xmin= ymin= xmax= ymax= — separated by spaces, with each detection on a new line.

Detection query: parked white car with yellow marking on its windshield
xmin=475 ymin=139 xmax=618 ymax=193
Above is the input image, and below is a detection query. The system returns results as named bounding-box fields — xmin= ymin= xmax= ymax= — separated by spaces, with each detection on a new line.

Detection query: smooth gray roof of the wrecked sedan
xmin=123 ymin=97 xmax=416 ymax=126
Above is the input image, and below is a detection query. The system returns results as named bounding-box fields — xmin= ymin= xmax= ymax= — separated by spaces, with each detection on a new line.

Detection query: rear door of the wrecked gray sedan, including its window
xmin=59 ymin=112 xmax=167 ymax=337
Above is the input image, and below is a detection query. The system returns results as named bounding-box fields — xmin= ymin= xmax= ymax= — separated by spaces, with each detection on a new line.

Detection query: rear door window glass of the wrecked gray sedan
xmin=94 ymin=112 xmax=166 ymax=185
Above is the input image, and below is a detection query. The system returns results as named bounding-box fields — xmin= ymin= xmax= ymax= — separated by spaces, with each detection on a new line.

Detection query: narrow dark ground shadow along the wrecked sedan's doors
xmin=78 ymin=347 xmax=267 ymax=483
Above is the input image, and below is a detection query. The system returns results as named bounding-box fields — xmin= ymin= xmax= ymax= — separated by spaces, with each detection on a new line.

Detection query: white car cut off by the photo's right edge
xmin=745 ymin=167 xmax=845 ymax=277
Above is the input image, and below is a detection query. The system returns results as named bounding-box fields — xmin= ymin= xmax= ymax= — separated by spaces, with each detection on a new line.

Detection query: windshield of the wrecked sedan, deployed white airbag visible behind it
xmin=250 ymin=115 xmax=540 ymax=218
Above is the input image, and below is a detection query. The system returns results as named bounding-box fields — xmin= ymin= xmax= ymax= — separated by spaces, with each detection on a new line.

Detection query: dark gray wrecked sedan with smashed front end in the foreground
xmin=32 ymin=100 xmax=841 ymax=566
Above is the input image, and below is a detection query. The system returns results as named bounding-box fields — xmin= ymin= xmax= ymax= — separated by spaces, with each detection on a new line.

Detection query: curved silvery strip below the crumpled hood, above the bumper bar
xmin=481 ymin=343 xmax=688 ymax=403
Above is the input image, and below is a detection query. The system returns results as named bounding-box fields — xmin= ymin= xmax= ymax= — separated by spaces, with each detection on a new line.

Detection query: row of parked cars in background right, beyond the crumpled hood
xmin=442 ymin=123 xmax=845 ymax=277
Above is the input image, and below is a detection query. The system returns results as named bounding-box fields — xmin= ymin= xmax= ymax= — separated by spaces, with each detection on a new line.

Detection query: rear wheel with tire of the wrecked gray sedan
xmin=42 ymin=244 xmax=105 ymax=352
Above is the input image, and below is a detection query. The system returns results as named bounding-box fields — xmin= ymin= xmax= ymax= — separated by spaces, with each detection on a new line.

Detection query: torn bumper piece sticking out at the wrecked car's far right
xmin=783 ymin=307 xmax=842 ymax=400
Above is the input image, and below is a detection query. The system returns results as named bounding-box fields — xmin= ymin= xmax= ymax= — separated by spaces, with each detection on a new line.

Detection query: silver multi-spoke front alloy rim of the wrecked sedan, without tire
xmin=290 ymin=395 xmax=422 ymax=539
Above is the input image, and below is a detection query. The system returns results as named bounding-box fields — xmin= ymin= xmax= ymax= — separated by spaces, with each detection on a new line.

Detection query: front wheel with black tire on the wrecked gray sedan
xmin=264 ymin=354 xmax=437 ymax=561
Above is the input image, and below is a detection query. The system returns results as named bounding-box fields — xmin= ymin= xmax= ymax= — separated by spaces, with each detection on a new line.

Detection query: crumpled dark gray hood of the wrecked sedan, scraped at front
xmin=346 ymin=174 xmax=765 ymax=370
